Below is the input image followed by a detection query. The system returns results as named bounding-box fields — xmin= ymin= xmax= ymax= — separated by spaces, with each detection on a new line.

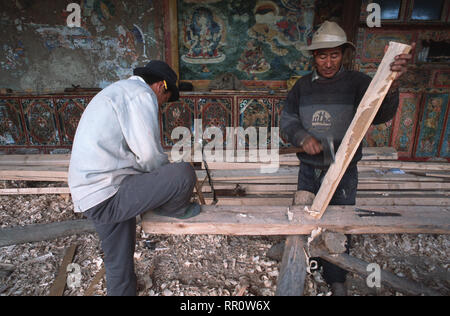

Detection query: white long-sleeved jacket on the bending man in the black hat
xmin=69 ymin=76 xmax=169 ymax=212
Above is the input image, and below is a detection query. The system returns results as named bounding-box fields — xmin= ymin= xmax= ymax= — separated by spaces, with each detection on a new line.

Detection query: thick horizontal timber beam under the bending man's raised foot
xmin=142 ymin=205 xmax=450 ymax=235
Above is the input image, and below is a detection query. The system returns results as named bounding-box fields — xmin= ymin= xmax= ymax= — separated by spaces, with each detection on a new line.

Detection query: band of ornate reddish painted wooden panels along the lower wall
xmin=0 ymin=89 xmax=450 ymax=160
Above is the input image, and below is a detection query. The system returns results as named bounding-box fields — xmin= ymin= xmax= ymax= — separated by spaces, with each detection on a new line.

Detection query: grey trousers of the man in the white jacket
xmin=84 ymin=162 xmax=197 ymax=296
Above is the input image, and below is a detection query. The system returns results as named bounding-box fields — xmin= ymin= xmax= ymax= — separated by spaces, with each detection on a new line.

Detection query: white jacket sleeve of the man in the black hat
xmin=118 ymin=93 xmax=169 ymax=172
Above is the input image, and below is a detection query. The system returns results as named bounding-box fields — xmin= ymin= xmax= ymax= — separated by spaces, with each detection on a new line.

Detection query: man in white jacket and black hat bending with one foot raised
xmin=69 ymin=60 xmax=200 ymax=296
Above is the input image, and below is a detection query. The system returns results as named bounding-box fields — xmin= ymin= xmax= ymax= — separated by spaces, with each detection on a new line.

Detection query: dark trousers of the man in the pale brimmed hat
xmin=297 ymin=163 xmax=358 ymax=284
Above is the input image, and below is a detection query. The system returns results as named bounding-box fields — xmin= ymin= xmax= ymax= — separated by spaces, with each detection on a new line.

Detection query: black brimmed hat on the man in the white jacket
xmin=133 ymin=60 xmax=180 ymax=102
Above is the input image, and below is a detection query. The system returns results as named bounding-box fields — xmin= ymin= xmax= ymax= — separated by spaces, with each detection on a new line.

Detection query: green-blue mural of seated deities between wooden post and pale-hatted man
xmin=178 ymin=0 xmax=314 ymax=80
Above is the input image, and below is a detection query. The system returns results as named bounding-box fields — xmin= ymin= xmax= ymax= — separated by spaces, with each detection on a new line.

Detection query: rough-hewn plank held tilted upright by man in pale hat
xmin=311 ymin=42 xmax=411 ymax=219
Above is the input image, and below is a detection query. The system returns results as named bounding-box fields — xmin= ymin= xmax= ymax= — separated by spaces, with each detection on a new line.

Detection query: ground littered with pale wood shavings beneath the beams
xmin=0 ymin=183 xmax=450 ymax=296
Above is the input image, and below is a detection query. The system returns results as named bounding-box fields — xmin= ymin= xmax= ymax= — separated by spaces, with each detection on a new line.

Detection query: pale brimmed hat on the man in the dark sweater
xmin=300 ymin=21 xmax=355 ymax=53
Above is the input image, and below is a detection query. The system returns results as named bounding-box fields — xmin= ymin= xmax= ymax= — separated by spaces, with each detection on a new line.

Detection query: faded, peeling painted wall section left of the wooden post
xmin=0 ymin=0 xmax=164 ymax=93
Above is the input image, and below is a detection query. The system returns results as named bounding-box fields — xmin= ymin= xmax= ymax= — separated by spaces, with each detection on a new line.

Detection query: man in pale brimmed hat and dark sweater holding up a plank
xmin=280 ymin=21 xmax=415 ymax=295
